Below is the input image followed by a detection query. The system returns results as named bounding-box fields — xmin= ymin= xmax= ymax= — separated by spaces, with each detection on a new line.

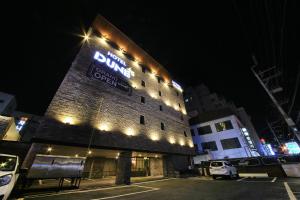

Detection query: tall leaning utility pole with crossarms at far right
xmin=251 ymin=56 xmax=300 ymax=142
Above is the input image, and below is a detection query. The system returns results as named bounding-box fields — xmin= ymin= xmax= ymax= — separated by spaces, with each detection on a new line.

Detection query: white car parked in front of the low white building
xmin=209 ymin=161 xmax=239 ymax=179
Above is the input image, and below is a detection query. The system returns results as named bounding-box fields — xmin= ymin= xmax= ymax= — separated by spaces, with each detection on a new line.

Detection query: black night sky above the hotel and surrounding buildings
xmin=0 ymin=0 xmax=300 ymax=137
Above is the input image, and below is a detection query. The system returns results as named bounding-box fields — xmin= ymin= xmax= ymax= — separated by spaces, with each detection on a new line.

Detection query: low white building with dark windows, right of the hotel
xmin=191 ymin=115 xmax=259 ymax=160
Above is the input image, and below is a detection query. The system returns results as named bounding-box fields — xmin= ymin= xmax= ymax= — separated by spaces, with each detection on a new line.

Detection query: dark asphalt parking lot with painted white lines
xmin=19 ymin=177 xmax=300 ymax=200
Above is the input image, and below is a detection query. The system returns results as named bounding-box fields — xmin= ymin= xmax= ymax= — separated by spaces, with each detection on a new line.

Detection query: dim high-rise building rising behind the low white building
xmin=184 ymin=84 xmax=265 ymax=155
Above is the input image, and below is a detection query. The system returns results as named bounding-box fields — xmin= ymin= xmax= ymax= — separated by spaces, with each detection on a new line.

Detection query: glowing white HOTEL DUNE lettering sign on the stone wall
xmin=94 ymin=51 xmax=134 ymax=78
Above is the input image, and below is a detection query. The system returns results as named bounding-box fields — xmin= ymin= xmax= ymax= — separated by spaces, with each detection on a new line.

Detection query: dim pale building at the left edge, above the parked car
xmin=0 ymin=92 xmax=17 ymax=116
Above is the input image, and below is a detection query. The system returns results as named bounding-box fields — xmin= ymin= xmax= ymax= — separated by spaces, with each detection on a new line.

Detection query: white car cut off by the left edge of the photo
xmin=0 ymin=154 xmax=19 ymax=200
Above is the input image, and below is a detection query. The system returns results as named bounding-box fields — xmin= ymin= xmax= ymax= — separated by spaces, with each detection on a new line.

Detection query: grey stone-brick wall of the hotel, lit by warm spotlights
xmin=35 ymin=16 xmax=194 ymax=155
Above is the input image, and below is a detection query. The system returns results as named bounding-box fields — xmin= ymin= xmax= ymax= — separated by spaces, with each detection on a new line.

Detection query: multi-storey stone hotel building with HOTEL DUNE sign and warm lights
xmin=23 ymin=16 xmax=194 ymax=184
